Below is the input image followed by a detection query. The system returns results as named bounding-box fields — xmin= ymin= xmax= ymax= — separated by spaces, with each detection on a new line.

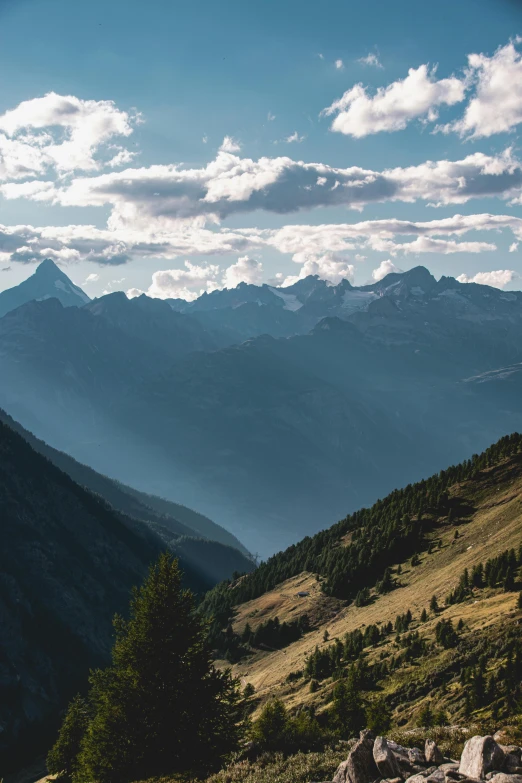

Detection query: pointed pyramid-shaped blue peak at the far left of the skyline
xmin=0 ymin=258 xmax=90 ymax=318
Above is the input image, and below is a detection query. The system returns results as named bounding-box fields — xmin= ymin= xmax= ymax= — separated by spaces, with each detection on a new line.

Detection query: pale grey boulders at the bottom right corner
xmin=324 ymin=731 xmax=522 ymax=783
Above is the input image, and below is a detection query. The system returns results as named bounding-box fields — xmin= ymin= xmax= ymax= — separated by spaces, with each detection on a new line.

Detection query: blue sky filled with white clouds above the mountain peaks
xmin=0 ymin=0 xmax=522 ymax=299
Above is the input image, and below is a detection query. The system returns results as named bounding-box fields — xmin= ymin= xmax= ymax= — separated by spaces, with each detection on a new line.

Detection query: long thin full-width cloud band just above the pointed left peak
xmin=0 ymin=208 xmax=522 ymax=272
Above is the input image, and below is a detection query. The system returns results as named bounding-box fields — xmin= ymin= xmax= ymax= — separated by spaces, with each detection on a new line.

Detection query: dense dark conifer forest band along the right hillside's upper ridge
xmin=202 ymin=433 xmax=522 ymax=652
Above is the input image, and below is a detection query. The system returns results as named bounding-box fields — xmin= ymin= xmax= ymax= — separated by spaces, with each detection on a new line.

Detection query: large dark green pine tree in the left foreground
xmin=68 ymin=554 xmax=240 ymax=783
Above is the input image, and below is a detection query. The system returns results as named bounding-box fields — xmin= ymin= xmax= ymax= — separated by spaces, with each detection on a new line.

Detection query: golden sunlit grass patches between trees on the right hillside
xmin=226 ymin=455 xmax=522 ymax=720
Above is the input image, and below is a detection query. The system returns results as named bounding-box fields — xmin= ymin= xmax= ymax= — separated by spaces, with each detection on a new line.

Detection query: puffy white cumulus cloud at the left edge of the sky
xmin=0 ymin=92 xmax=139 ymax=180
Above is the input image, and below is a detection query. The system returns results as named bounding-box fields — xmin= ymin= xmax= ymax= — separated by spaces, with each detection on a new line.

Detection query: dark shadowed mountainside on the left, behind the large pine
xmin=0 ymin=415 xmax=253 ymax=772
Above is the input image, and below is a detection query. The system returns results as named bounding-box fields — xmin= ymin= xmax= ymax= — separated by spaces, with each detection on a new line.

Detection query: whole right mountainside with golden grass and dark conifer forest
xmin=203 ymin=435 xmax=522 ymax=728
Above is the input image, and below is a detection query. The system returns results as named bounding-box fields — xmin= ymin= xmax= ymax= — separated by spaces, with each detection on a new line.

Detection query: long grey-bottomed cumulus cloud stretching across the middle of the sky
xmin=16 ymin=148 xmax=522 ymax=231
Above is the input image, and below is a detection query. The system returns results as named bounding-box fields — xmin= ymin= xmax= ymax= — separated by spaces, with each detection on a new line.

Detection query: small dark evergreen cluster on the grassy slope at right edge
xmin=446 ymin=544 xmax=522 ymax=606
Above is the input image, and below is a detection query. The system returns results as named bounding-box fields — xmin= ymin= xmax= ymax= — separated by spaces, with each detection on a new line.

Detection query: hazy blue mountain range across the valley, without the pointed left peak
xmin=0 ymin=262 xmax=522 ymax=556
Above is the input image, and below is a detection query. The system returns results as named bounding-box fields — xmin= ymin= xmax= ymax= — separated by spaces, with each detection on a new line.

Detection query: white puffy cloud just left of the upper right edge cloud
xmin=322 ymin=65 xmax=466 ymax=139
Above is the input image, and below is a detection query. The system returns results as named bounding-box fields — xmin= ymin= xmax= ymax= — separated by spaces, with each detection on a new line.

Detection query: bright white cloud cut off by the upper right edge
xmin=438 ymin=40 xmax=522 ymax=139
